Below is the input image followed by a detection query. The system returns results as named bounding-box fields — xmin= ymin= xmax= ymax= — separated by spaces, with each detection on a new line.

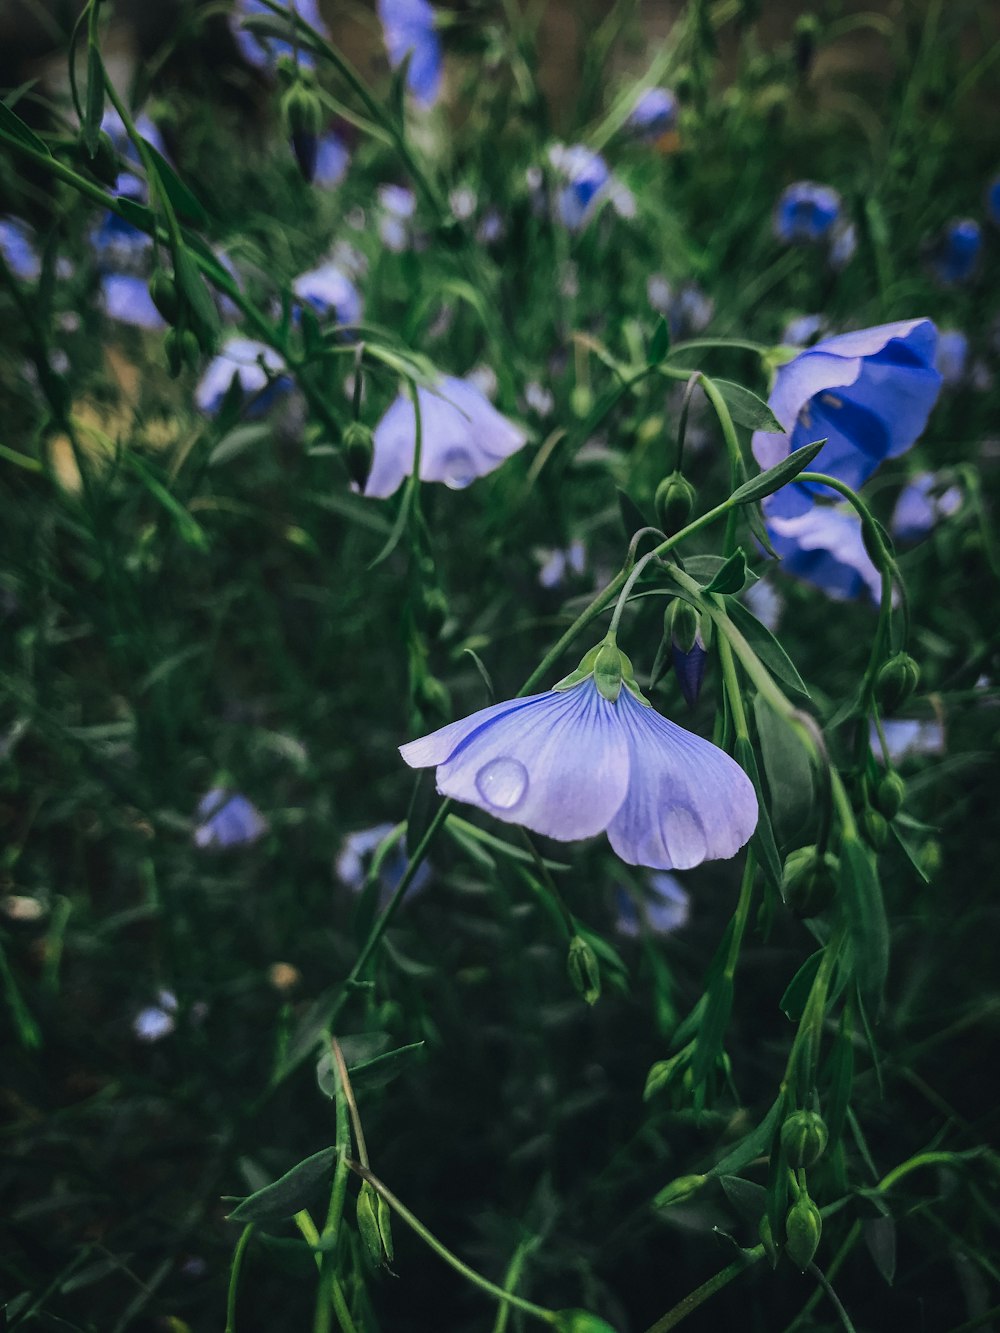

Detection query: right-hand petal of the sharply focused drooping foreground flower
xmin=608 ymin=690 xmax=757 ymax=870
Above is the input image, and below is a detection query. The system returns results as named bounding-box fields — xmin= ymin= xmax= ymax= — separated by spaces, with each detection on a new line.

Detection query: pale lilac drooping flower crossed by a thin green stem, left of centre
xmin=364 ymin=375 xmax=527 ymax=499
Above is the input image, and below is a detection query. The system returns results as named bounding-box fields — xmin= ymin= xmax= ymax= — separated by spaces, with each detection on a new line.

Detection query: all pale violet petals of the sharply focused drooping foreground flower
xmin=400 ymin=676 xmax=757 ymax=870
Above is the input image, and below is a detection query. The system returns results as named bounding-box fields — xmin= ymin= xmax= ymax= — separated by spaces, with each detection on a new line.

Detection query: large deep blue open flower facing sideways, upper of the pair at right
xmin=752 ymin=320 xmax=941 ymax=519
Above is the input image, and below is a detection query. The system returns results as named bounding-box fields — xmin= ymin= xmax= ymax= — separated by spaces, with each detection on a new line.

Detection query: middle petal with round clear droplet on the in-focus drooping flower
xmin=426 ymin=680 xmax=629 ymax=842
